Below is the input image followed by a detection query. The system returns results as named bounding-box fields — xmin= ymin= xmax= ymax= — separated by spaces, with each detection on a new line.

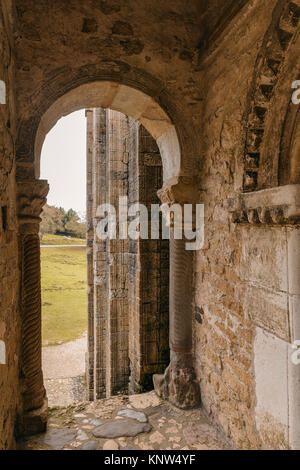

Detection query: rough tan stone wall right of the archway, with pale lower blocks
xmin=194 ymin=1 xmax=298 ymax=449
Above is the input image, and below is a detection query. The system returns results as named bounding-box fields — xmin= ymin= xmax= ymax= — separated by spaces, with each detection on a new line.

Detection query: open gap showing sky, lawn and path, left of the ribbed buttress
xmin=39 ymin=110 xmax=87 ymax=407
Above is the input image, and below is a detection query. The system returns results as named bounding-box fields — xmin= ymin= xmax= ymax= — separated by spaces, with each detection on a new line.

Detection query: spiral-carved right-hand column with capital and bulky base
xmin=153 ymin=178 xmax=200 ymax=408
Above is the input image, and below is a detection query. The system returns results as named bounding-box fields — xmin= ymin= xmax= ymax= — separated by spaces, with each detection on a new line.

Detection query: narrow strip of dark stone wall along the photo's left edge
xmin=0 ymin=1 xmax=20 ymax=450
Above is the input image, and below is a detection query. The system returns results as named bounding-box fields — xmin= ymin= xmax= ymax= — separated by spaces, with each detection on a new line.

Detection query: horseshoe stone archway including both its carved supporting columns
xmin=17 ymin=81 xmax=200 ymax=434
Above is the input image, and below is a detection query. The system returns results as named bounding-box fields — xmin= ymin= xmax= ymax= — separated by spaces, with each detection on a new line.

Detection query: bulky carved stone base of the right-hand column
xmin=153 ymin=351 xmax=200 ymax=409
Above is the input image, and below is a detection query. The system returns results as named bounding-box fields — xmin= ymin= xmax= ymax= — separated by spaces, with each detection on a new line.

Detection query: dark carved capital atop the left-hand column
xmin=17 ymin=179 xmax=49 ymax=223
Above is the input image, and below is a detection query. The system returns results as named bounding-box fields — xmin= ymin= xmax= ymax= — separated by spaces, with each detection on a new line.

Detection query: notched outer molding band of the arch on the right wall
xmin=243 ymin=0 xmax=300 ymax=192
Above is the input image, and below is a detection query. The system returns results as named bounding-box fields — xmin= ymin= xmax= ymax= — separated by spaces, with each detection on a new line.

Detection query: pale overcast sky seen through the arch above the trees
xmin=41 ymin=110 xmax=86 ymax=213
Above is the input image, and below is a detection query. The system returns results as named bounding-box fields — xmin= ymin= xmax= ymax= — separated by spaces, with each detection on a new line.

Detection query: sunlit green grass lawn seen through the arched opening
xmin=41 ymin=246 xmax=87 ymax=346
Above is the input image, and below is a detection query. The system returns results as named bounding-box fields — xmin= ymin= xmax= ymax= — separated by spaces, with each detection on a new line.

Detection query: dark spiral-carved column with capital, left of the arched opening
xmin=18 ymin=180 xmax=49 ymax=435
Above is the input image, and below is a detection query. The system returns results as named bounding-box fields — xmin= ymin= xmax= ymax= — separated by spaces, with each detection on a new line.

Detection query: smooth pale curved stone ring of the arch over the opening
xmin=34 ymin=81 xmax=181 ymax=181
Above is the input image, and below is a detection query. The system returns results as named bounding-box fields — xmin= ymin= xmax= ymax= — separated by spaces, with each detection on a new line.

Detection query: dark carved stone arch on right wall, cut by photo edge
xmin=242 ymin=0 xmax=300 ymax=192
